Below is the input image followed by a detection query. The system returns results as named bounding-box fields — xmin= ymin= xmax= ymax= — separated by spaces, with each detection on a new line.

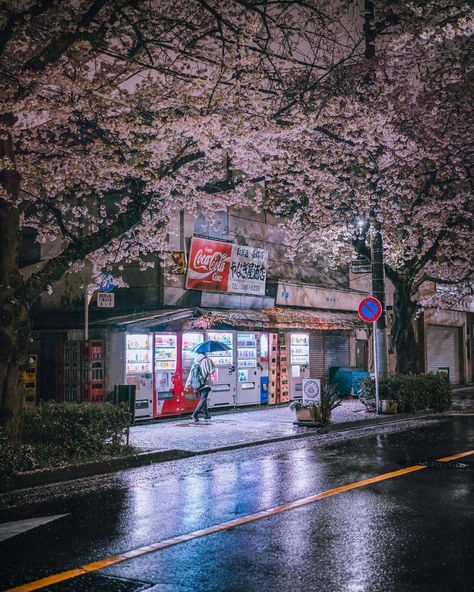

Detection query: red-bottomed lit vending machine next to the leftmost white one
xmin=154 ymin=333 xmax=179 ymax=416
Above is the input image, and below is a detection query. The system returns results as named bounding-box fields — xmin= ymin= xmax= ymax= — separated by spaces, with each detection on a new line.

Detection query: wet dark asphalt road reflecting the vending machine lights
xmin=0 ymin=417 xmax=474 ymax=592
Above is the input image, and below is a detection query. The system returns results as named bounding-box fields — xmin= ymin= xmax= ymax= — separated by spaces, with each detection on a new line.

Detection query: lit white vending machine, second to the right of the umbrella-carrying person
xmin=235 ymin=333 xmax=261 ymax=405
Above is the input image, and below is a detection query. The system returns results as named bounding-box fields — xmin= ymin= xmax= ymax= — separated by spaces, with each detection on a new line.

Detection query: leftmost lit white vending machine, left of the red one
xmin=125 ymin=333 xmax=153 ymax=419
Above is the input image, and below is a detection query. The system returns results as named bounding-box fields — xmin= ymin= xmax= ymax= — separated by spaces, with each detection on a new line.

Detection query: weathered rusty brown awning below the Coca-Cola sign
xmin=183 ymin=308 xmax=363 ymax=331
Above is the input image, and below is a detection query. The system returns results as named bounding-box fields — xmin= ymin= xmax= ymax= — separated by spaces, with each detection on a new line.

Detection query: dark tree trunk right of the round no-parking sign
xmin=391 ymin=280 xmax=419 ymax=374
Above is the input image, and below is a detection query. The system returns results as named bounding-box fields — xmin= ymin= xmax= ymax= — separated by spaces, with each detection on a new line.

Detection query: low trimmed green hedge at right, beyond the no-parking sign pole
xmin=361 ymin=374 xmax=451 ymax=413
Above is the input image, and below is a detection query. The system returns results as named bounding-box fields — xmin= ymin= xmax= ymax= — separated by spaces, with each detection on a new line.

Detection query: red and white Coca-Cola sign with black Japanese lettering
xmin=186 ymin=237 xmax=267 ymax=296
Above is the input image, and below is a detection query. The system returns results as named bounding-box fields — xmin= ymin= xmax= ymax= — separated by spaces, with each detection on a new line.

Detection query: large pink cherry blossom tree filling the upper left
xmin=0 ymin=0 xmax=359 ymax=439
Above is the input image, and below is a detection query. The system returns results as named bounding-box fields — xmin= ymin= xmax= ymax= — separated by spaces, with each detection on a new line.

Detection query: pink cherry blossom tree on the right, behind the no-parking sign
xmin=266 ymin=1 xmax=474 ymax=372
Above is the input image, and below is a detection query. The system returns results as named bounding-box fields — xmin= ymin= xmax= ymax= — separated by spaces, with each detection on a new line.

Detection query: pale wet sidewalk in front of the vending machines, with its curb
xmin=1 ymin=399 xmax=458 ymax=490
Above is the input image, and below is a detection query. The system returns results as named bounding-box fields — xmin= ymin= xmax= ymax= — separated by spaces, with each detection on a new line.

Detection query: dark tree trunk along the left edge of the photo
xmin=0 ymin=114 xmax=30 ymax=444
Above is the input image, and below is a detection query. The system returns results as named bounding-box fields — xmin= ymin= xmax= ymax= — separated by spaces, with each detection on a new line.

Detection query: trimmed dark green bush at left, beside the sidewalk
xmin=23 ymin=402 xmax=131 ymax=465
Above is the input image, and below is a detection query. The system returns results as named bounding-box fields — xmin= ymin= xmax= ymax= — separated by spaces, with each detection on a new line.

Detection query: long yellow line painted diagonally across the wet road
xmin=5 ymin=450 xmax=474 ymax=592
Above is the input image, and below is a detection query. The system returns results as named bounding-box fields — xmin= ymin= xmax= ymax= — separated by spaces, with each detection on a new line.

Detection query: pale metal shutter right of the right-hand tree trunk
xmin=426 ymin=325 xmax=461 ymax=384
